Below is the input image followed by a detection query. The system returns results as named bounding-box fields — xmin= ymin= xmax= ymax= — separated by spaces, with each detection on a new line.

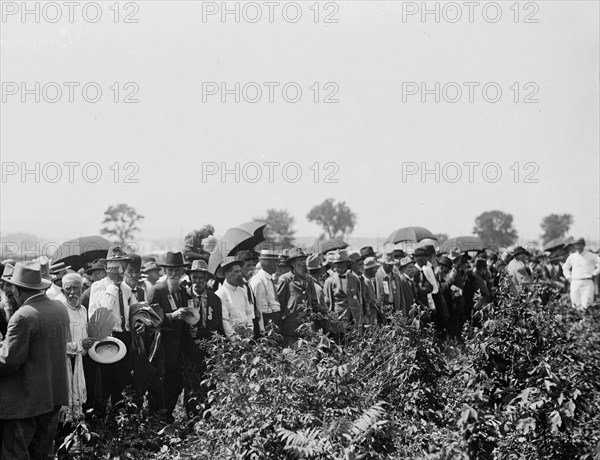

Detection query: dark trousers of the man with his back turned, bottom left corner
xmin=0 ymin=406 xmax=60 ymax=460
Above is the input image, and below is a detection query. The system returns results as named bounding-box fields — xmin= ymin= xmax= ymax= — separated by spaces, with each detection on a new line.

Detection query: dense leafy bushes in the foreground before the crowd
xmin=56 ymin=274 xmax=600 ymax=460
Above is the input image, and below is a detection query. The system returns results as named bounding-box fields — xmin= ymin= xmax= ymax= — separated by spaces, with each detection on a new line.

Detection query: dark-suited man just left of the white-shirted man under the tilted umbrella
xmin=182 ymin=259 xmax=225 ymax=418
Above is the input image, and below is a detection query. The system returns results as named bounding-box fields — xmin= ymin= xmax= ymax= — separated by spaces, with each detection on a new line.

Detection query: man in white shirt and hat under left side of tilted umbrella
xmin=216 ymin=256 xmax=254 ymax=339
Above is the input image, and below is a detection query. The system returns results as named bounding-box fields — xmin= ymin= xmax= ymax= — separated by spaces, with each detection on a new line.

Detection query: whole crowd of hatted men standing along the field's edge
xmin=0 ymin=226 xmax=600 ymax=460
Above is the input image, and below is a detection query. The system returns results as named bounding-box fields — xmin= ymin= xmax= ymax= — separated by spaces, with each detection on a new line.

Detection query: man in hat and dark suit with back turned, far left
xmin=0 ymin=262 xmax=71 ymax=460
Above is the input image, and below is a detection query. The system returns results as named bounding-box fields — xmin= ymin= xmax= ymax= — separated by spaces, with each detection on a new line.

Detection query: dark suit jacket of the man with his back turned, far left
xmin=0 ymin=294 xmax=71 ymax=419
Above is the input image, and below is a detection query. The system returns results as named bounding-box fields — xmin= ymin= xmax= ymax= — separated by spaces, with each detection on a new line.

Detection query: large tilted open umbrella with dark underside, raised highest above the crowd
xmin=208 ymin=222 xmax=267 ymax=274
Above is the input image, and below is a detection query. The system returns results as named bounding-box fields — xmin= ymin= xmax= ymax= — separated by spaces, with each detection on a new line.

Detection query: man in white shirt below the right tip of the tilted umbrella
xmin=250 ymin=249 xmax=281 ymax=332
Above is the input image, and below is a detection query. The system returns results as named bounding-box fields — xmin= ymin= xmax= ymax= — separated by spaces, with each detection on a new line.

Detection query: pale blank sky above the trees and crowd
xmin=0 ymin=1 xmax=600 ymax=248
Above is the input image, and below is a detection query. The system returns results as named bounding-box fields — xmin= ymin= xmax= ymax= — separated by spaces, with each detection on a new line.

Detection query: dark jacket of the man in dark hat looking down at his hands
xmin=148 ymin=281 xmax=190 ymax=372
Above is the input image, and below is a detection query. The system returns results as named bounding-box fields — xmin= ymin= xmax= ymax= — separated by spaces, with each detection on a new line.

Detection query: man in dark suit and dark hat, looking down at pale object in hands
xmin=148 ymin=252 xmax=191 ymax=422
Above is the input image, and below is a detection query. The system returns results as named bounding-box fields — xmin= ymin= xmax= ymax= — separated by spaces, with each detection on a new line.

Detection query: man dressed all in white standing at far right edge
xmin=563 ymin=238 xmax=600 ymax=310
